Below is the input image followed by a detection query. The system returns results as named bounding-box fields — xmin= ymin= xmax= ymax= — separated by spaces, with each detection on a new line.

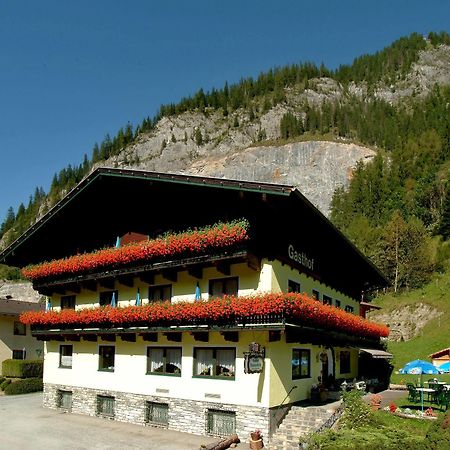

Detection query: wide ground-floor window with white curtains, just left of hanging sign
xmin=194 ymin=347 xmax=236 ymax=379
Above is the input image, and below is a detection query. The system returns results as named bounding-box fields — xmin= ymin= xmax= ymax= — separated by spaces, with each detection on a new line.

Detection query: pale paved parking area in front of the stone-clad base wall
xmin=0 ymin=393 xmax=215 ymax=450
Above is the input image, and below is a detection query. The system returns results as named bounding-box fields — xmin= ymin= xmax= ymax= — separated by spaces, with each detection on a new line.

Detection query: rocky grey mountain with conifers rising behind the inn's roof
xmin=0 ymin=33 xmax=450 ymax=268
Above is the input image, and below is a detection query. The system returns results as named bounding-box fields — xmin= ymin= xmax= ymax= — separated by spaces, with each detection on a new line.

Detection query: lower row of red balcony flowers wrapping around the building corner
xmin=20 ymin=293 xmax=389 ymax=339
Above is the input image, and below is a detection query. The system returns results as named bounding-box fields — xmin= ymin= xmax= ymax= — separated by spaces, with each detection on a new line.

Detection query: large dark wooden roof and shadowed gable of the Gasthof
xmin=0 ymin=168 xmax=387 ymax=298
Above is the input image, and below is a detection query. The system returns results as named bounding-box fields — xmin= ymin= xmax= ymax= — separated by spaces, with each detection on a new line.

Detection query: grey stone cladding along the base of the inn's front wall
xmin=43 ymin=383 xmax=273 ymax=441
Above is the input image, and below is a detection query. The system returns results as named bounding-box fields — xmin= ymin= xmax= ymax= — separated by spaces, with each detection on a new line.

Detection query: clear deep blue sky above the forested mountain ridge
xmin=0 ymin=0 xmax=450 ymax=222
